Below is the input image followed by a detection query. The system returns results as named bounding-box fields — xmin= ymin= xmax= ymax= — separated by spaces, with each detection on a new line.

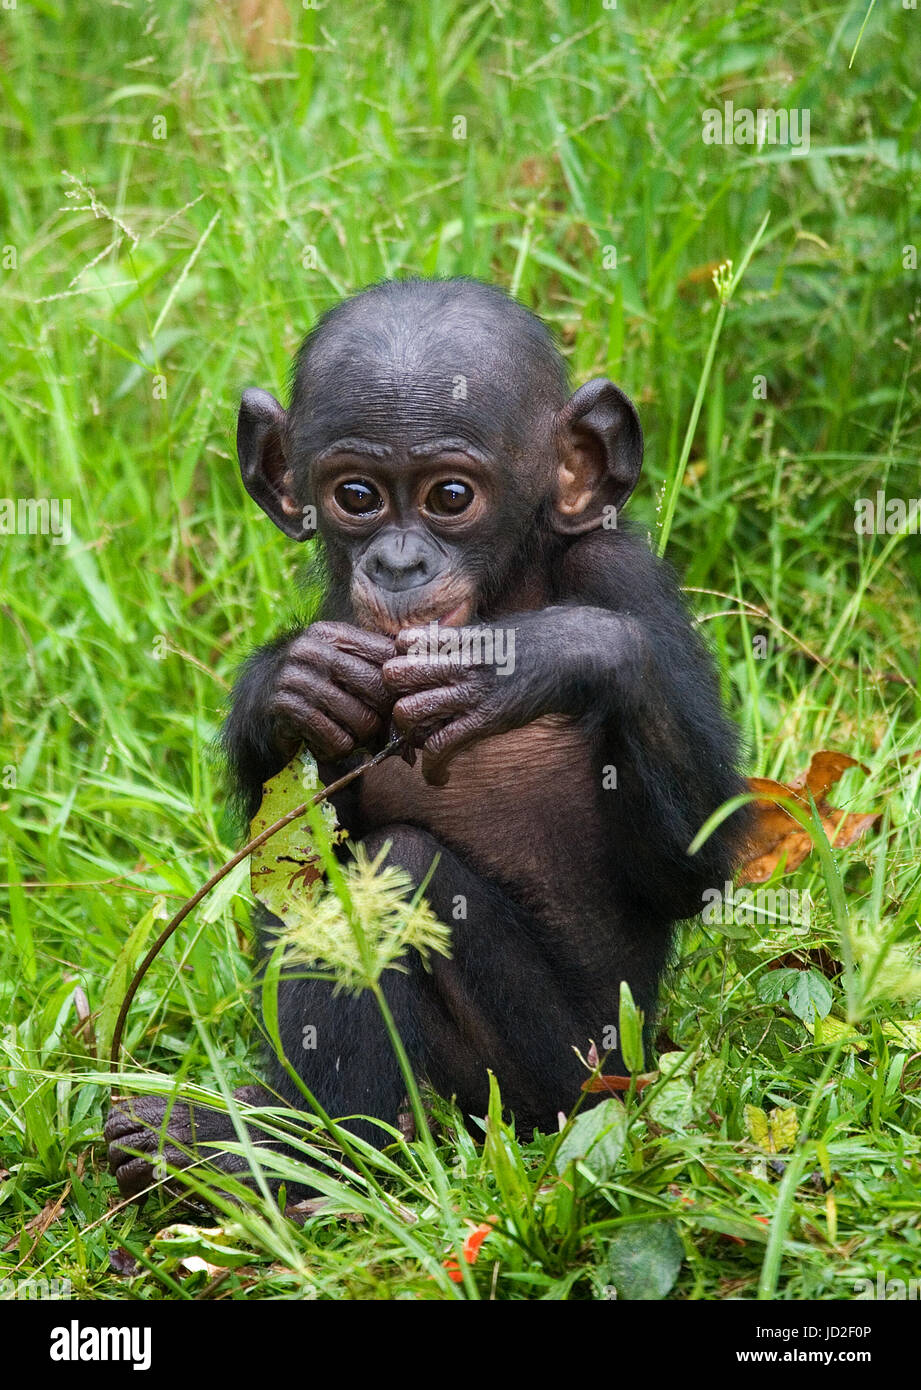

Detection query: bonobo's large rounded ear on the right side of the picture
xmin=553 ymin=377 xmax=643 ymax=535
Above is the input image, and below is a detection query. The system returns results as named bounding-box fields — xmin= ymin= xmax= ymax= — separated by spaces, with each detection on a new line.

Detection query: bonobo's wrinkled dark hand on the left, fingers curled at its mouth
xmin=271 ymin=623 xmax=396 ymax=762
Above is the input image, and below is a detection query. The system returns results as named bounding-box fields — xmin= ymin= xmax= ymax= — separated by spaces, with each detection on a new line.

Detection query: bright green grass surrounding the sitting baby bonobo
xmin=0 ymin=0 xmax=921 ymax=1300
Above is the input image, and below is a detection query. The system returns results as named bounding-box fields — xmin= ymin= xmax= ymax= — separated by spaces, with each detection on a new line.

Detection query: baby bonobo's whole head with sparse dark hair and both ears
xmin=238 ymin=279 xmax=643 ymax=632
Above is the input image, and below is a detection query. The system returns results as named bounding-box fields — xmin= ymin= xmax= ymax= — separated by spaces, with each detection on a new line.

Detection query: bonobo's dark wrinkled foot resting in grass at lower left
xmin=103 ymin=1086 xmax=274 ymax=1197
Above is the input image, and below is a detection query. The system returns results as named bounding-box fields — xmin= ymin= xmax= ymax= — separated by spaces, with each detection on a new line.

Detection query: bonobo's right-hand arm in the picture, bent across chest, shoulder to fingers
xmin=383 ymin=531 xmax=746 ymax=919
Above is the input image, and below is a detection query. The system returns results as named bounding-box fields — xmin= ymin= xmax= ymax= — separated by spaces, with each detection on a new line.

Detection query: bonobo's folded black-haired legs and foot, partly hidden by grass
xmin=106 ymin=826 xmax=615 ymax=1195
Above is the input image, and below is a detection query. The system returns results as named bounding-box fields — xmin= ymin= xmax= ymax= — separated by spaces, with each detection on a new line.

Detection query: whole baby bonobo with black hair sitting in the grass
xmin=106 ymin=279 xmax=742 ymax=1195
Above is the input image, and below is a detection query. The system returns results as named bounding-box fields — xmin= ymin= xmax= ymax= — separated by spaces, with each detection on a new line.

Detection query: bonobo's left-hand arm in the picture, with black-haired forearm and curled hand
xmin=222 ymin=623 xmax=395 ymax=819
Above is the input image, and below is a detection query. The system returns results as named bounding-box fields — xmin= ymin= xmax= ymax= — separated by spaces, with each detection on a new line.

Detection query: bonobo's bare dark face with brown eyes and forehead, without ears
xmin=289 ymin=336 xmax=550 ymax=634
